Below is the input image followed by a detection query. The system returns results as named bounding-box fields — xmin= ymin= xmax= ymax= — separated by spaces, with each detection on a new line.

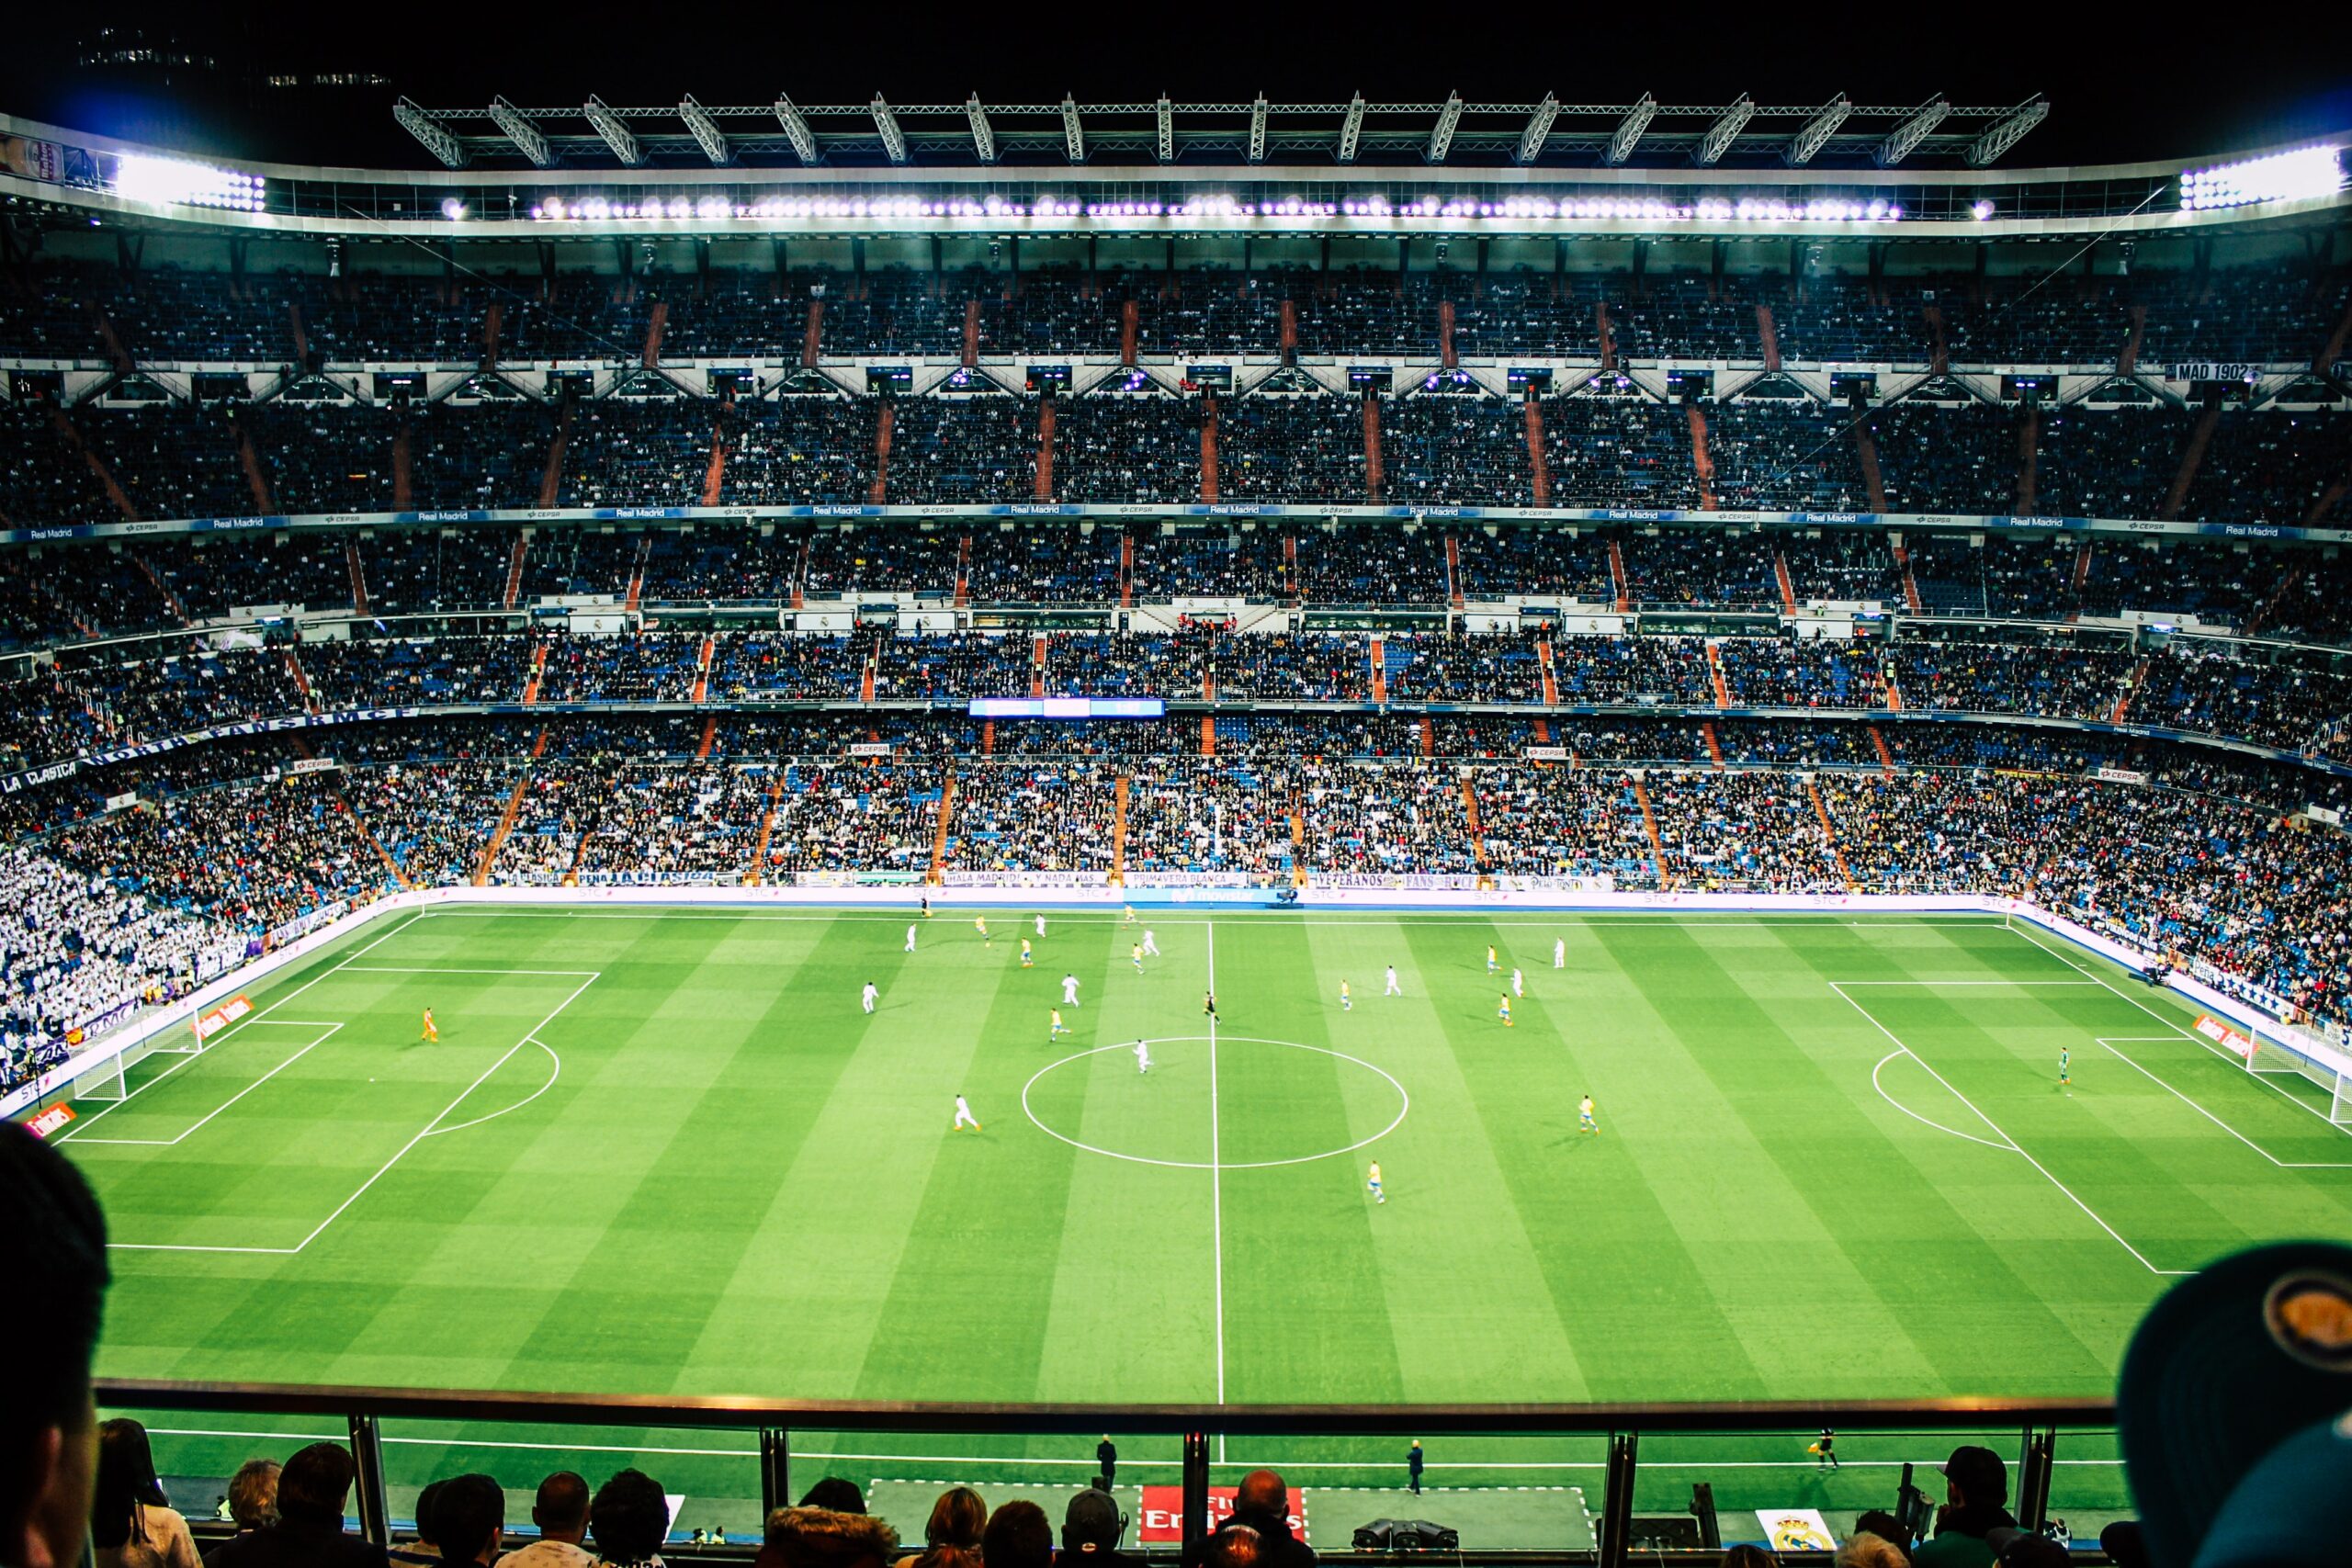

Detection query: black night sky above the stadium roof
xmin=0 ymin=0 xmax=2352 ymax=167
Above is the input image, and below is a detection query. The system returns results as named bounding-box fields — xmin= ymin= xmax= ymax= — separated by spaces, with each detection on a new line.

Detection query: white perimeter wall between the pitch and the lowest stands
xmin=0 ymin=877 xmax=2352 ymax=1117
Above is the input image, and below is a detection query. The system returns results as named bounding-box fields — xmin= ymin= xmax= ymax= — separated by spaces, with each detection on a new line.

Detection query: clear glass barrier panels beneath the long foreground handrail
xmin=101 ymin=1384 xmax=2131 ymax=1565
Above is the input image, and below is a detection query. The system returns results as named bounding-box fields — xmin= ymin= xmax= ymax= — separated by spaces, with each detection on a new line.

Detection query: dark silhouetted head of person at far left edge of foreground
xmin=0 ymin=1122 xmax=106 ymax=1568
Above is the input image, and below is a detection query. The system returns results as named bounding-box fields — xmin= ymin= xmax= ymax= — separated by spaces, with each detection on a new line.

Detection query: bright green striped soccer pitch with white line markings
xmin=63 ymin=908 xmax=2352 ymax=1523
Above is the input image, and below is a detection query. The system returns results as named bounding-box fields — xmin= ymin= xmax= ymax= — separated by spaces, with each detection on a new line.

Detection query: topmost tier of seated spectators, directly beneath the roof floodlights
xmin=14 ymin=261 xmax=2345 ymax=369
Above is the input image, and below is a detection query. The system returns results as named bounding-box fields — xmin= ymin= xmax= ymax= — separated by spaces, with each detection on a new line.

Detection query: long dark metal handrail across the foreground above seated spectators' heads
xmin=96 ymin=1378 xmax=2114 ymax=1437
